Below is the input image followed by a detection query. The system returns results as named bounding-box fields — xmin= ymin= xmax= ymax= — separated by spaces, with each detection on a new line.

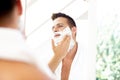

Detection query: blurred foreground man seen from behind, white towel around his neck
xmin=0 ymin=0 xmax=69 ymax=80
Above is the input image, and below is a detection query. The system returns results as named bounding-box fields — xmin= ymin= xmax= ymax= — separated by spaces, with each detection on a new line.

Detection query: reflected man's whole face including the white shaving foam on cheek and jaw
xmin=52 ymin=17 xmax=75 ymax=51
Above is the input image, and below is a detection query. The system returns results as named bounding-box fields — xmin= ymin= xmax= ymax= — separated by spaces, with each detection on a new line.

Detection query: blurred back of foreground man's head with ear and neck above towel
xmin=0 ymin=0 xmax=22 ymax=29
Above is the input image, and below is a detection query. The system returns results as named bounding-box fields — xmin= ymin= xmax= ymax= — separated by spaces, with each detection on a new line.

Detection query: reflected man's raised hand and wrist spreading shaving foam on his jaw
xmin=49 ymin=35 xmax=70 ymax=72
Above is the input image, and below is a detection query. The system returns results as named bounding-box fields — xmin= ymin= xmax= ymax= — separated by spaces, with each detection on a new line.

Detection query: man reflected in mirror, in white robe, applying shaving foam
xmin=49 ymin=13 xmax=80 ymax=80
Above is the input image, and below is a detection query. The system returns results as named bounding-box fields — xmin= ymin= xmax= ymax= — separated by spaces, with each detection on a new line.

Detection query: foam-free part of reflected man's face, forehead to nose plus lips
xmin=52 ymin=17 xmax=69 ymax=38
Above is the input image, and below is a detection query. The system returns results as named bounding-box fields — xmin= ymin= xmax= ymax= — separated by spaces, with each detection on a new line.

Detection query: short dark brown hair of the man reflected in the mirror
xmin=51 ymin=12 xmax=76 ymax=28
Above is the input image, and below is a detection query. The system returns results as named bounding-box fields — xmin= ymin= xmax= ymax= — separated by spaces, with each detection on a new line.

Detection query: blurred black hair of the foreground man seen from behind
xmin=0 ymin=0 xmax=17 ymax=17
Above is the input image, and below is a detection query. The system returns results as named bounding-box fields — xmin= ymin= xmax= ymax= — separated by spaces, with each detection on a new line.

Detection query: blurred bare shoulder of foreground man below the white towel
xmin=0 ymin=60 xmax=52 ymax=80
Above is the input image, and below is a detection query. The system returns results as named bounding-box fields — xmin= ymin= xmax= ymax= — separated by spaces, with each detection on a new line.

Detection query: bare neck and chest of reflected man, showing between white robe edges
xmin=61 ymin=43 xmax=78 ymax=80
